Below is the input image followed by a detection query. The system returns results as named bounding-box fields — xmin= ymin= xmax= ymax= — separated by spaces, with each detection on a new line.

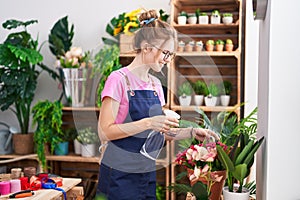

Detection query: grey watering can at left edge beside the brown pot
xmin=0 ymin=122 xmax=14 ymax=155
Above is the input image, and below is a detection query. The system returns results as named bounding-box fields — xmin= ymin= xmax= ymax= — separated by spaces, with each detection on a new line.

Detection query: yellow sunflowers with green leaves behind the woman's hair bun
xmin=102 ymin=8 xmax=142 ymax=44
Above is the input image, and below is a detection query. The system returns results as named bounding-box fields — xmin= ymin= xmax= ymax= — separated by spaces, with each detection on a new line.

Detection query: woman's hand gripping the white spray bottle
xmin=149 ymin=115 xmax=179 ymax=133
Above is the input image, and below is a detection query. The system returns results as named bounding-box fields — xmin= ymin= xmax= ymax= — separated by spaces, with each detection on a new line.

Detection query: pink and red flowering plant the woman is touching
xmin=175 ymin=139 xmax=229 ymax=199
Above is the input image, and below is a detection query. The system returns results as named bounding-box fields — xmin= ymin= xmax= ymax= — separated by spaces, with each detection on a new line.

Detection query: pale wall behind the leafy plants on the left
xmin=0 ymin=0 xmax=170 ymax=129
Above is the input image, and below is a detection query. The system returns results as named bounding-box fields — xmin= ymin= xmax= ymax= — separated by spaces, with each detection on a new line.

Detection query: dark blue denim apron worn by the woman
xmin=97 ymin=72 xmax=164 ymax=200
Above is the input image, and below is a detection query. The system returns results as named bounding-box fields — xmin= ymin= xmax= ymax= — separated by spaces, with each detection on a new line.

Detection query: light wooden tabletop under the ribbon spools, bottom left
xmin=0 ymin=178 xmax=81 ymax=200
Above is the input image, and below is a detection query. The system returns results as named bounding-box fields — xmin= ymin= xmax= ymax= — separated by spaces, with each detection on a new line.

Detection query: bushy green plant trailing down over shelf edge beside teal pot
xmin=32 ymin=100 xmax=65 ymax=169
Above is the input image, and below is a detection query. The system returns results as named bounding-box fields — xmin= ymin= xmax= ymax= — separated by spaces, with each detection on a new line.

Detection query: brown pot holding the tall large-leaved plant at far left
xmin=13 ymin=133 xmax=34 ymax=155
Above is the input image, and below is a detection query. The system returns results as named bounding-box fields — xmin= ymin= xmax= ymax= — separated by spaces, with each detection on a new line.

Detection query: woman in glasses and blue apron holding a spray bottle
xmin=97 ymin=10 xmax=214 ymax=200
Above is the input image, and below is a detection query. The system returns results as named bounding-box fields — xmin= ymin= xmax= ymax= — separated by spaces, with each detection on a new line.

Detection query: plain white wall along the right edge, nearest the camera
xmin=257 ymin=0 xmax=300 ymax=200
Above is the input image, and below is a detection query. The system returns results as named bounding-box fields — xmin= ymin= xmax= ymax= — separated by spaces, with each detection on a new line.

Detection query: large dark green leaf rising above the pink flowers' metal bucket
xmin=48 ymin=16 xmax=74 ymax=59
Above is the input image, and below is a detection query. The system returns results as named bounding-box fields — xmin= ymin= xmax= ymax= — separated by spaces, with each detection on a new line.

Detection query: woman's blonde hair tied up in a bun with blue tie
xmin=133 ymin=10 xmax=177 ymax=53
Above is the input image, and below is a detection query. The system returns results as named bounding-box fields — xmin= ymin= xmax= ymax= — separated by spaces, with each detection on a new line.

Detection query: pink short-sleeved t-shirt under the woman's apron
xmin=101 ymin=67 xmax=165 ymax=124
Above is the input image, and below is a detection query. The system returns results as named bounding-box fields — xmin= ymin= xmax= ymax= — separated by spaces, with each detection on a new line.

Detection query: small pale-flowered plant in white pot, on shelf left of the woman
xmin=77 ymin=127 xmax=100 ymax=157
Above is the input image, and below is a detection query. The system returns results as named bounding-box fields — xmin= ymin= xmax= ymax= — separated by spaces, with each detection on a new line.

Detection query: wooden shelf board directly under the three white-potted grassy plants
xmin=171 ymin=105 xmax=237 ymax=112
